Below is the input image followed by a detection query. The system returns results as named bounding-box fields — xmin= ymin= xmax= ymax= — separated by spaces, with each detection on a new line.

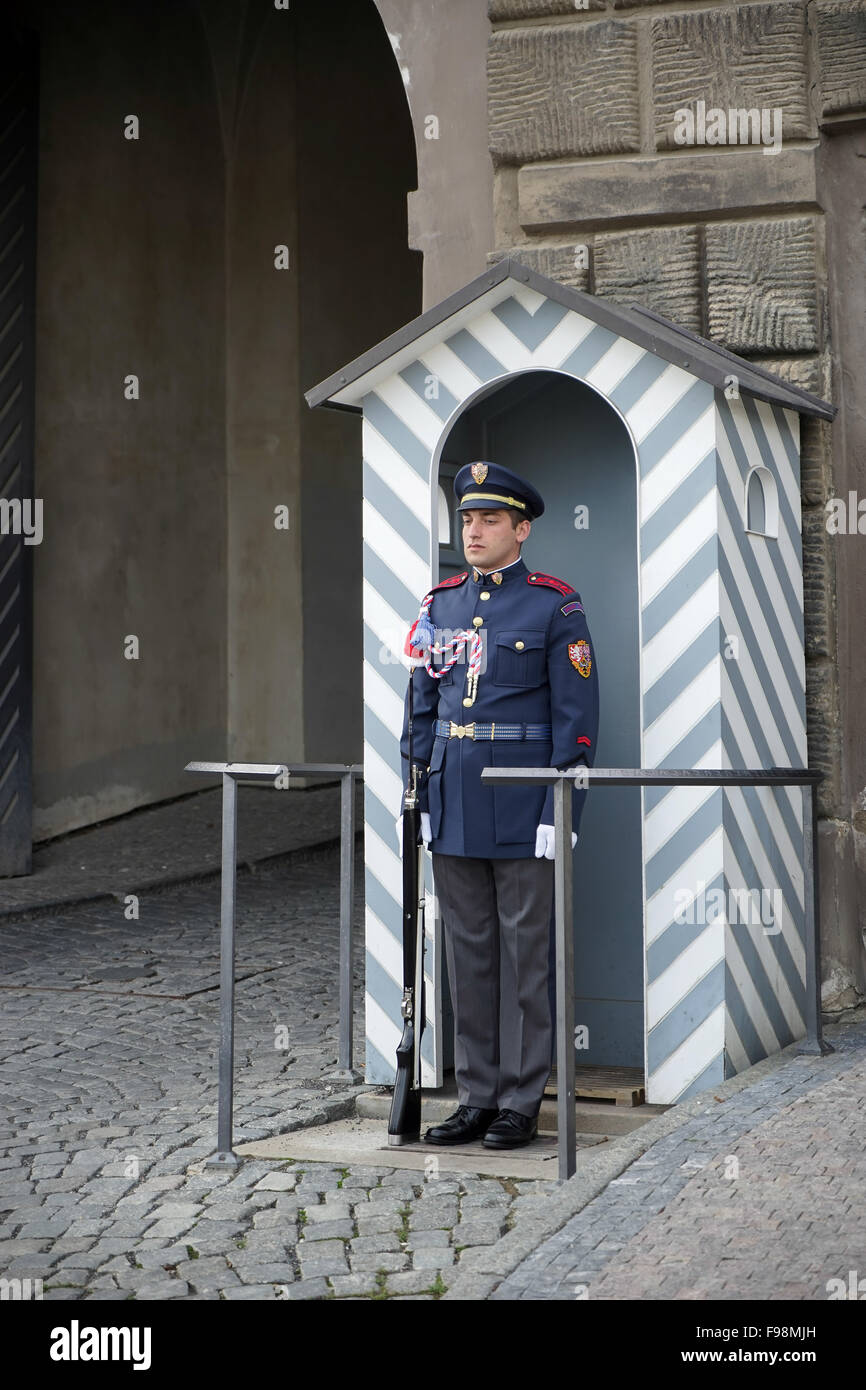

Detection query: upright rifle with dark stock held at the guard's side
xmin=388 ymin=670 xmax=424 ymax=1145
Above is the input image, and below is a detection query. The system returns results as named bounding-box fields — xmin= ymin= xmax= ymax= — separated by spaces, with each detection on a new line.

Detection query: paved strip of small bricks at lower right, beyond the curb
xmin=489 ymin=1009 xmax=866 ymax=1300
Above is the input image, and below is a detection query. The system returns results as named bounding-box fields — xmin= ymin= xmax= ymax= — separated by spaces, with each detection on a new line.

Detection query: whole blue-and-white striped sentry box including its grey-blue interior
xmin=306 ymin=259 xmax=835 ymax=1104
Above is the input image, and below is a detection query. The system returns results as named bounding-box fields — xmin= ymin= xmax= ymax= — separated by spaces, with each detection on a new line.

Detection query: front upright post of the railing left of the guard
xmin=206 ymin=771 xmax=240 ymax=1168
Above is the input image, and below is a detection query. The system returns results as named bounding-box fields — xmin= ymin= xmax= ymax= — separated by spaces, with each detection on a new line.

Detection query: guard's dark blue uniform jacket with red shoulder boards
xmin=400 ymin=560 xmax=599 ymax=859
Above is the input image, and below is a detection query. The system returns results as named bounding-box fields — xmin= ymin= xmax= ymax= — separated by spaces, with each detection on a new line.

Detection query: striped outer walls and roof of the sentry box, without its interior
xmin=307 ymin=261 xmax=834 ymax=1104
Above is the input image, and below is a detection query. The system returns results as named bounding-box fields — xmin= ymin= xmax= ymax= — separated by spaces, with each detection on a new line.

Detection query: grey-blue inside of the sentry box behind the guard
xmin=439 ymin=371 xmax=644 ymax=1068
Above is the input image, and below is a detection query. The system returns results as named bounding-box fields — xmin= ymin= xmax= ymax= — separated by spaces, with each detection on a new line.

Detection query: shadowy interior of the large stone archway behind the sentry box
xmin=0 ymin=0 xmax=423 ymax=845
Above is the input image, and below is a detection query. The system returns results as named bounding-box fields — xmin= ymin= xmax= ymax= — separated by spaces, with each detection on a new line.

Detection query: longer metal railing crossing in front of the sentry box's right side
xmin=481 ymin=766 xmax=833 ymax=1182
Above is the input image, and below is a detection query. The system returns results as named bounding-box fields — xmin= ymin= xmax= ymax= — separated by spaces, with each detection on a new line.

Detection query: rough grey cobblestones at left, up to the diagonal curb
xmin=0 ymin=849 xmax=556 ymax=1300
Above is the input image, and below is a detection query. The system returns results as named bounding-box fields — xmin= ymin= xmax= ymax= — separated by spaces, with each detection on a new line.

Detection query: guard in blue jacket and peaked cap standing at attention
xmin=398 ymin=461 xmax=598 ymax=1148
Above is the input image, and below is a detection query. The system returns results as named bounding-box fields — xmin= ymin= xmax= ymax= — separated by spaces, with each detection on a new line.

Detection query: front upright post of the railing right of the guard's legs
xmin=553 ymin=777 xmax=577 ymax=1182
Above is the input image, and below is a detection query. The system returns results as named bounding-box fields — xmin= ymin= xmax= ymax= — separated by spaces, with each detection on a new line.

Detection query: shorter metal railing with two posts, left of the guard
xmin=183 ymin=763 xmax=364 ymax=1168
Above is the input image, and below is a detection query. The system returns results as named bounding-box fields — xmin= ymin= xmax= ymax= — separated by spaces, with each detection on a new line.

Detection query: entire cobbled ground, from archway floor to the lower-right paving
xmin=0 ymin=806 xmax=866 ymax=1300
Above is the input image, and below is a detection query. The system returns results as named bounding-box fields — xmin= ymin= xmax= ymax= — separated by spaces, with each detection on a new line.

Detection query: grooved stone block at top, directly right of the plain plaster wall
xmin=488 ymin=19 xmax=641 ymax=164
